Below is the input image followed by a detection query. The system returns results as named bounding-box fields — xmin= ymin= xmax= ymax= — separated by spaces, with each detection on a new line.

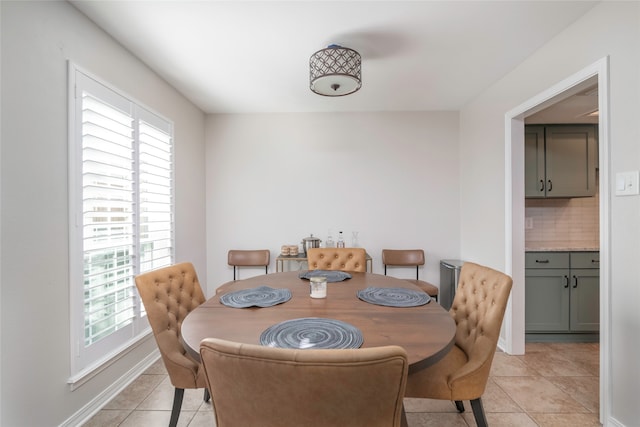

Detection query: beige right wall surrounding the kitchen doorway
xmin=460 ymin=1 xmax=640 ymax=426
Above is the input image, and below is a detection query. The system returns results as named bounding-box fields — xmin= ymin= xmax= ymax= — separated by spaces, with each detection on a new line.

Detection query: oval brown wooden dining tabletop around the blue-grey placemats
xmin=181 ymin=271 xmax=456 ymax=372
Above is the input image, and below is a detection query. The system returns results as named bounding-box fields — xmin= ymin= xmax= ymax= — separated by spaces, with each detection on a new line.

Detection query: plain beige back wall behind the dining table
xmin=206 ymin=112 xmax=460 ymax=296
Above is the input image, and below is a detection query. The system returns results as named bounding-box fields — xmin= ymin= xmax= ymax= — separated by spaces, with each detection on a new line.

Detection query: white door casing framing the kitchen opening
xmin=505 ymin=57 xmax=614 ymax=425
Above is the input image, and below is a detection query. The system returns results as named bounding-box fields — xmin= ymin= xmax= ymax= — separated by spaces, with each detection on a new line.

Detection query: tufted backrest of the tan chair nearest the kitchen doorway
xmin=449 ymin=262 xmax=513 ymax=389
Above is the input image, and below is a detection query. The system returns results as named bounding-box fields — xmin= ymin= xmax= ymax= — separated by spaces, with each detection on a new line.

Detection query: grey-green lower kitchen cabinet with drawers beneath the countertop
xmin=525 ymin=252 xmax=600 ymax=333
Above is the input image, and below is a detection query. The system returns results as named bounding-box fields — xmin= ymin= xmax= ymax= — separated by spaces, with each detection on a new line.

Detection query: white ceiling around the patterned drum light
xmin=70 ymin=0 xmax=598 ymax=113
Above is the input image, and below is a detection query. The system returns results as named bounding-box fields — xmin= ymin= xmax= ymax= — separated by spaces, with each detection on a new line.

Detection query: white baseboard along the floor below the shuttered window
xmin=60 ymin=349 xmax=160 ymax=427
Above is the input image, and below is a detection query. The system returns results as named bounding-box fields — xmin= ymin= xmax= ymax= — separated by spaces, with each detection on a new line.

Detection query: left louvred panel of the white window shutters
xmin=82 ymin=90 xmax=136 ymax=346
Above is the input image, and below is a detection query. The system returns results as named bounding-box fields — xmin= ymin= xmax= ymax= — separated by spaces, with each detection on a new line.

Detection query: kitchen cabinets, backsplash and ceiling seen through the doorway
xmin=525 ymin=77 xmax=600 ymax=342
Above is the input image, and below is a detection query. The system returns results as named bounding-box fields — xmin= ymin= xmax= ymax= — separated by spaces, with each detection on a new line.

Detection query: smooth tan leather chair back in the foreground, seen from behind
xmin=200 ymin=338 xmax=408 ymax=427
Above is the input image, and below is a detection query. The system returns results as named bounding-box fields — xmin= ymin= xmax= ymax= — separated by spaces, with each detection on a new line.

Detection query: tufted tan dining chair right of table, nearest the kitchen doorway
xmin=406 ymin=262 xmax=513 ymax=427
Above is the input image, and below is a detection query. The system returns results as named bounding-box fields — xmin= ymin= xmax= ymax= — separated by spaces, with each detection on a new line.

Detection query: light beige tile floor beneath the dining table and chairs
xmin=85 ymin=343 xmax=600 ymax=427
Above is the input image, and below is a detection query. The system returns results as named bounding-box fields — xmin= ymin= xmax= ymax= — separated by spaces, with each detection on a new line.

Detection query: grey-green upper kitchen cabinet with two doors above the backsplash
xmin=525 ymin=125 xmax=598 ymax=198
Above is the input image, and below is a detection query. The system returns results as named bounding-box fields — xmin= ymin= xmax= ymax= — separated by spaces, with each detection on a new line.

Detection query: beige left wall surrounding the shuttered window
xmin=0 ymin=1 xmax=206 ymax=426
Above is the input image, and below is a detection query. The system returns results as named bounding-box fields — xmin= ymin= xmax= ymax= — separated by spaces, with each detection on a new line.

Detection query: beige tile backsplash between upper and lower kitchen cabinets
xmin=525 ymin=195 xmax=600 ymax=248
